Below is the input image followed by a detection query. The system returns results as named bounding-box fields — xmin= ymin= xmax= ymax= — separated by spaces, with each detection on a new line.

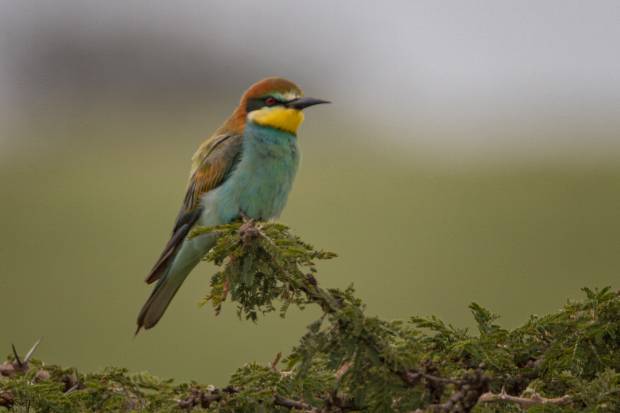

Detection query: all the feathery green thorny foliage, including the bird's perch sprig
xmin=0 ymin=221 xmax=620 ymax=413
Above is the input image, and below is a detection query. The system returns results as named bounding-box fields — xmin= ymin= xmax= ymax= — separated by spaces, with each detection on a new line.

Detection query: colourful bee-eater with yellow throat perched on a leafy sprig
xmin=136 ymin=77 xmax=329 ymax=334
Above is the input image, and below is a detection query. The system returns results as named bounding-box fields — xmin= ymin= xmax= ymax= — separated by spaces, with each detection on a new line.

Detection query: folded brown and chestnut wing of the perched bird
xmin=146 ymin=134 xmax=243 ymax=284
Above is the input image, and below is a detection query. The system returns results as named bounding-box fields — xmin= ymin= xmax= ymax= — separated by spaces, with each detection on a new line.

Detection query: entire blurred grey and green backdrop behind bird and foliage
xmin=0 ymin=0 xmax=620 ymax=384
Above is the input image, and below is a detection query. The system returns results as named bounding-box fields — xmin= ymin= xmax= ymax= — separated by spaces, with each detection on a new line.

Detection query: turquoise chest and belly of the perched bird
xmin=208 ymin=130 xmax=299 ymax=220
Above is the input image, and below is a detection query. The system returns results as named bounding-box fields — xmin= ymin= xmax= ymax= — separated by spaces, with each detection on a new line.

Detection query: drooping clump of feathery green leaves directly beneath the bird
xmin=190 ymin=222 xmax=336 ymax=321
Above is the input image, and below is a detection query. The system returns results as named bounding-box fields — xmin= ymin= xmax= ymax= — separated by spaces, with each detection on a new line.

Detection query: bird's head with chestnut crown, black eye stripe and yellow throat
xmin=239 ymin=77 xmax=329 ymax=135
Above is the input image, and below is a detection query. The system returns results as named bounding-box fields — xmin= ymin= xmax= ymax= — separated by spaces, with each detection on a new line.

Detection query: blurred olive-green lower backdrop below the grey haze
xmin=0 ymin=108 xmax=620 ymax=384
